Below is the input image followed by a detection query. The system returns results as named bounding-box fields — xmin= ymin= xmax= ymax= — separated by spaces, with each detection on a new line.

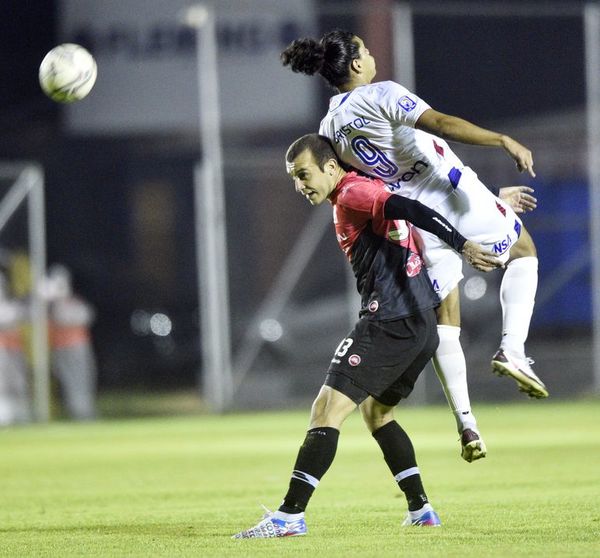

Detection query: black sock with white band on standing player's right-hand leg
xmin=373 ymin=420 xmax=428 ymax=511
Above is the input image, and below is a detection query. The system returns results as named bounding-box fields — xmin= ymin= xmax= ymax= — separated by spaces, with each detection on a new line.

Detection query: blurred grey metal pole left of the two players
xmin=185 ymin=5 xmax=233 ymax=412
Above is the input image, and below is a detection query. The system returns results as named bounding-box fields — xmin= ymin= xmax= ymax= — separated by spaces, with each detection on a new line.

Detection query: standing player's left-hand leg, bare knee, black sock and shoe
xmin=232 ymin=385 xmax=357 ymax=539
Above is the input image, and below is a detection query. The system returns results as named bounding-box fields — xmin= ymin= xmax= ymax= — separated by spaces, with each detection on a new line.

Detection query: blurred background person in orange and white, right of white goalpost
xmin=44 ymin=264 xmax=97 ymax=420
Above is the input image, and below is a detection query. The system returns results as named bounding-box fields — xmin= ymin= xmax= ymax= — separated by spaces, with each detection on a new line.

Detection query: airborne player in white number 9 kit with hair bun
xmin=281 ymin=30 xmax=548 ymax=462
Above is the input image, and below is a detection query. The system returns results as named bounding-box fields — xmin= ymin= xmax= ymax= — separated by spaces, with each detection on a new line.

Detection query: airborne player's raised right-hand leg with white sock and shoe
xmin=492 ymin=227 xmax=548 ymax=398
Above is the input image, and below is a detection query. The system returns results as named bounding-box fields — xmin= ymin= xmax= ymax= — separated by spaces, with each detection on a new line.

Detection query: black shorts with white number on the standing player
xmin=325 ymin=309 xmax=439 ymax=406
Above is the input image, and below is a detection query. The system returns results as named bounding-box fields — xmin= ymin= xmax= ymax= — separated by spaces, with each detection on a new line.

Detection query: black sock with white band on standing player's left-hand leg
xmin=279 ymin=426 xmax=340 ymax=513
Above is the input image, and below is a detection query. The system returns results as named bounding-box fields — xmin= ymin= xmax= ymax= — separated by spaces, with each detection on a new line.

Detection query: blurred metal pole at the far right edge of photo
xmin=584 ymin=4 xmax=600 ymax=392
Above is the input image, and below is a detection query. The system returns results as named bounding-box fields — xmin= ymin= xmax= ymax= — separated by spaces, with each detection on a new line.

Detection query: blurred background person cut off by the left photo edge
xmin=0 ymin=273 xmax=31 ymax=426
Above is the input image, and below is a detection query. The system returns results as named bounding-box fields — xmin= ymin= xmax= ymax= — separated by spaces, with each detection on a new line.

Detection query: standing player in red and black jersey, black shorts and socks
xmin=234 ymin=134 xmax=501 ymax=538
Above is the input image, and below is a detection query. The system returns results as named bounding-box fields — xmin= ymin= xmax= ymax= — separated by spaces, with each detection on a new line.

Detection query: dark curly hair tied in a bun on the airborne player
xmin=281 ymin=29 xmax=360 ymax=89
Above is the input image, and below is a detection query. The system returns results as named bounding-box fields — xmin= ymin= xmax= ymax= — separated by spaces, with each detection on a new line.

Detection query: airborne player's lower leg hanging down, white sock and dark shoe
xmin=432 ymin=286 xmax=487 ymax=463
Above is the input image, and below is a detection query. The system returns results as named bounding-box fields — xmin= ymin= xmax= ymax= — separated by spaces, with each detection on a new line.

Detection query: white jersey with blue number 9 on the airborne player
xmin=319 ymin=81 xmax=464 ymax=207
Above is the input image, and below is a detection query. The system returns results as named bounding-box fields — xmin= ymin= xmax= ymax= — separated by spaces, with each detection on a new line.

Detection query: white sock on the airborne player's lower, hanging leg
xmin=433 ymin=325 xmax=478 ymax=434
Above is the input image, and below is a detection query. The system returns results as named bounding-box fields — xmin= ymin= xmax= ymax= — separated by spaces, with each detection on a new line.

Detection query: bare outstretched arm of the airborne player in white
xmin=415 ymin=108 xmax=535 ymax=176
